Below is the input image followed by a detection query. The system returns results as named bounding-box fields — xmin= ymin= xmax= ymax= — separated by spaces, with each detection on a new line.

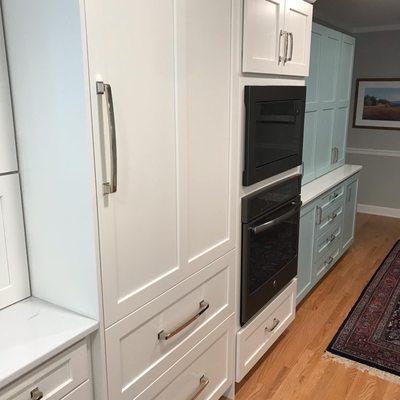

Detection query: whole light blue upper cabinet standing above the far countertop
xmin=302 ymin=24 xmax=355 ymax=185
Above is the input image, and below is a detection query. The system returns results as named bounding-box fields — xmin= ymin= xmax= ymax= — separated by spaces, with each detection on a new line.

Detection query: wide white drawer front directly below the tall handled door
xmin=106 ymin=252 xmax=235 ymax=400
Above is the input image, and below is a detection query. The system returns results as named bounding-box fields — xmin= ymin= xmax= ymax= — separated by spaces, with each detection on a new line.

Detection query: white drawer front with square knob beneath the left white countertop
xmin=0 ymin=341 xmax=89 ymax=400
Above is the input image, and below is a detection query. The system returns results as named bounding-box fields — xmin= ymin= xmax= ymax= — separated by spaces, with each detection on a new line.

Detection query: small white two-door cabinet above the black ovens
xmin=243 ymin=0 xmax=313 ymax=76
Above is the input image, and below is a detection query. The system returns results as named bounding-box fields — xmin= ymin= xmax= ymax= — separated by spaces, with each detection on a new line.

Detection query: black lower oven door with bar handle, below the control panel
xmin=240 ymin=201 xmax=301 ymax=325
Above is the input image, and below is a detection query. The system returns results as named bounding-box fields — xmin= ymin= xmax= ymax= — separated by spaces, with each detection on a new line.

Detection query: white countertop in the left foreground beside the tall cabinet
xmin=0 ymin=297 xmax=98 ymax=389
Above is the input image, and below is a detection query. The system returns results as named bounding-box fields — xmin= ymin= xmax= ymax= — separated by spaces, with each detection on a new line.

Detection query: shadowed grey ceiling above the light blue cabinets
xmin=314 ymin=0 xmax=400 ymax=32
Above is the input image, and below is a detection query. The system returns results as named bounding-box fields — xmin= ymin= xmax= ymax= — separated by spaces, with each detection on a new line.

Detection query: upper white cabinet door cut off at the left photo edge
xmin=0 ymin=13 xmax=18 ymax=174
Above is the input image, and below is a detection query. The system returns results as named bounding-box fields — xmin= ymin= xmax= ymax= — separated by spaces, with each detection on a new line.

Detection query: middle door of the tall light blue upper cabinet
xmin=315 ymin=25 xmax=342 ymax=178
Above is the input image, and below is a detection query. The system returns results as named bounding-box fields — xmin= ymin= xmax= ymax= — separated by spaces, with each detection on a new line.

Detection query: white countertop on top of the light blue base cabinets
xmin=301 ymin=164 xmax=362 ymax=206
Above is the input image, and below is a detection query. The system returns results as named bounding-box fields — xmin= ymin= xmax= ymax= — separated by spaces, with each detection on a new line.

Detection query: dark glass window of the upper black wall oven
xmin=254 ymin=100 xmax=300 ymax=168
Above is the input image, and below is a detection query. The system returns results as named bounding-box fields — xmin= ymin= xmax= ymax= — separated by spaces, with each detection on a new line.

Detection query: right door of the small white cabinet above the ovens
xmin=284 ymin=0 xmax=313 ymax=76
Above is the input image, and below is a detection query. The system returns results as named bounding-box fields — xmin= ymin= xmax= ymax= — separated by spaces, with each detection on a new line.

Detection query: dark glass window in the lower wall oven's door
xmin=248 ymin=214 xmax=299 ymax=294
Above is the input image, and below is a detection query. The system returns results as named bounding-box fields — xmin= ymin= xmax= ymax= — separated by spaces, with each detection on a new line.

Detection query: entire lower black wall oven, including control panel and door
xmin=240 ymin=175 xmax=301 ymax=326
